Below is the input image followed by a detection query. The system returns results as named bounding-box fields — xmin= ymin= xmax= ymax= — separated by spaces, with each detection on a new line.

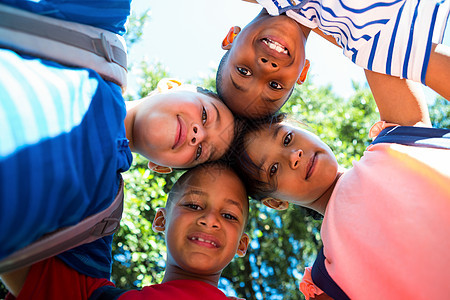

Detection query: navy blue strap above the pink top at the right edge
xmin=371 ymin=126 xmax=450 ymax=149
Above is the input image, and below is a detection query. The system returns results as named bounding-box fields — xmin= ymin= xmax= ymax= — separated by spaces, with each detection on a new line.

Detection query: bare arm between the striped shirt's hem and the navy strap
xmin=364 ymin=70 xmax=431 ymax=127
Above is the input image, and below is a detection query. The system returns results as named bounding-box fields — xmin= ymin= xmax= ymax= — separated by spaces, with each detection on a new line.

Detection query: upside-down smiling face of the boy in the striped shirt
xmin=218 ymin=14 xmax=306 ymax=118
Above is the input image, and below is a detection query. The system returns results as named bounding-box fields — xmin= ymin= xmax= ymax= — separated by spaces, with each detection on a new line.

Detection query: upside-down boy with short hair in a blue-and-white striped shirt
xmin=216 ymin=0 xmax=450 ymax=118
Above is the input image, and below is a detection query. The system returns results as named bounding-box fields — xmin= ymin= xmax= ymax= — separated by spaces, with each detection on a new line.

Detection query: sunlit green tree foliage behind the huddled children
xmin=0 ymin=8 xmax=450 ymax=300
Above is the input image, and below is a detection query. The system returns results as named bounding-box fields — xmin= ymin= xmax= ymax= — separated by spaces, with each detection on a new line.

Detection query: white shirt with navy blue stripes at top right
xmin=258 ymin=0 xmax=450 ymax=84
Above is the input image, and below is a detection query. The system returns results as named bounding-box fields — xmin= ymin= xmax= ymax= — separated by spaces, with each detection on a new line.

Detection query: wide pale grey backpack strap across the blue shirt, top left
xmin=0 ymin=4 xmax=127 ymax=91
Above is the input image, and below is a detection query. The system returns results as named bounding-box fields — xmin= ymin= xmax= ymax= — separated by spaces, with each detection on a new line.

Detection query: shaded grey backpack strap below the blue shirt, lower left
xmin=0 ymin=178 xmax=124 ymax=274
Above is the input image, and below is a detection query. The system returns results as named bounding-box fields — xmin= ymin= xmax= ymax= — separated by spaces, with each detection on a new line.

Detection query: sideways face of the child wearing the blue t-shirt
xmin=133 ymin=89 xmax=234 ymax=168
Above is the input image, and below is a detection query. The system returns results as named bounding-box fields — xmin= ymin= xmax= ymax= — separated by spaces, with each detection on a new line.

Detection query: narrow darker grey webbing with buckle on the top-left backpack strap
xmin=0 ymin=4 xmax=127 ymax=70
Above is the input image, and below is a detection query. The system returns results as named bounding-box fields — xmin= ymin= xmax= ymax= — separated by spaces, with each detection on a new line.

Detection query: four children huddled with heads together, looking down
xmin=0 ymin=0 xmax=450 ymax=299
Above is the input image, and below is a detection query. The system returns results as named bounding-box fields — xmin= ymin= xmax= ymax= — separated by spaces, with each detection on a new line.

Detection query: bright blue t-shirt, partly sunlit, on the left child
xmin=0 ymin=0 xmax=132 ymax=278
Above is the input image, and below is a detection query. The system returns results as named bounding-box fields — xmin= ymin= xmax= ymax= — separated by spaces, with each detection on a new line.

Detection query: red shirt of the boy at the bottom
xmin=5 ymin=257 xmax=228 ymax=300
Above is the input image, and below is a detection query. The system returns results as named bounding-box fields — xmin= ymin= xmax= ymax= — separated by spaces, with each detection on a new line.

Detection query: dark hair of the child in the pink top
xmin=230 ymin=113 xmax=323 ymax=220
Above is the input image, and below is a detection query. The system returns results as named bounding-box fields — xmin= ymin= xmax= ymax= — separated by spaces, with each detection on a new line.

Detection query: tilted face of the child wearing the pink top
xmin=246 ymin=123 xmax=338 ymax=206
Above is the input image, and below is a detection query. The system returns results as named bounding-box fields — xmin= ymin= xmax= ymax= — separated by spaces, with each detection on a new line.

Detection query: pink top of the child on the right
xmin=321 ymin=121 xmax=450 ymax=299
